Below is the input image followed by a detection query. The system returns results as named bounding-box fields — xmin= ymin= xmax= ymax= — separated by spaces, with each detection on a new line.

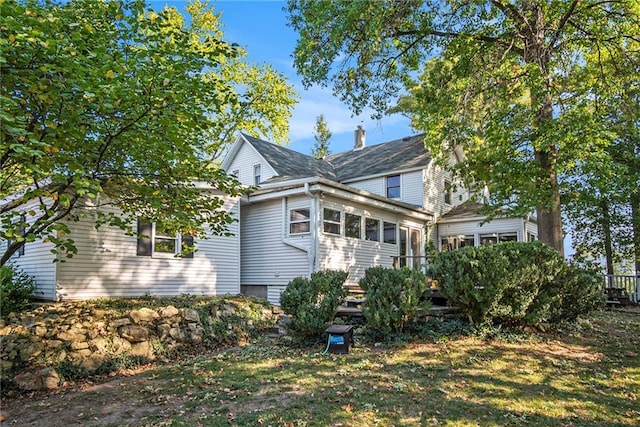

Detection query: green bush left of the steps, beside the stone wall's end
xmin=280 ymin=271 xmax=348 ymax=339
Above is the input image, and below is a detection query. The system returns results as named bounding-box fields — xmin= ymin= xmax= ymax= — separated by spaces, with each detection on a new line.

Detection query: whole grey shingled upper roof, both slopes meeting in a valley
xmin=242 ymin=133 xmax=431 ymax=182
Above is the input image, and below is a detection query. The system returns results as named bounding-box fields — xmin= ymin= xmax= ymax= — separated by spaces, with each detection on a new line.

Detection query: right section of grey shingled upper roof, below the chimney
xmin=324 ymin=134 xmax=431 ymax=182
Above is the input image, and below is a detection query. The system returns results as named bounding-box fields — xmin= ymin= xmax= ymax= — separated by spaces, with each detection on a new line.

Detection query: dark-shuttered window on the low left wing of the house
xmin=136 ymin=220 xmax=193 ymax=258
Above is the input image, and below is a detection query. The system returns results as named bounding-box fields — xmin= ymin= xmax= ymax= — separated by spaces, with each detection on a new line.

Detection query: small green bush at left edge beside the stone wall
xmin=0 ymin=265 xmax=36 ymax=317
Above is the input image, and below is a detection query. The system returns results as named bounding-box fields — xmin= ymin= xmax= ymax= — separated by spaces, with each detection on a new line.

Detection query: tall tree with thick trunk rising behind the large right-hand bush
xmin=288 ymin=0 xmax=640 ymax=253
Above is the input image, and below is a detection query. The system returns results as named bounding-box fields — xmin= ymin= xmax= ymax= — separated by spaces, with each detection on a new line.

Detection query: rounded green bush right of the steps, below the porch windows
xmin=359 ymin=267 xmax=430 ymax=337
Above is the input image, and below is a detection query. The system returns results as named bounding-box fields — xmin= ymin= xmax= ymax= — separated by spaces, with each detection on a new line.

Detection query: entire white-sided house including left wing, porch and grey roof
xmin=5 ymin=128 xmax=537 ymax=304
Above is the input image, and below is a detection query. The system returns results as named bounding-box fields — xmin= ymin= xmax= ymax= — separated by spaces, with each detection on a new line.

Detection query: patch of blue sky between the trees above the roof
xmin=149 ymin=0 xmax=415 ymax=154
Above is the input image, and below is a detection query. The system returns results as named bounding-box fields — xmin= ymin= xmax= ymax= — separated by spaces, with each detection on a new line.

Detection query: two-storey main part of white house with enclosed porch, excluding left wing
xmin=223 ymin=128 xmax=537 ymax=303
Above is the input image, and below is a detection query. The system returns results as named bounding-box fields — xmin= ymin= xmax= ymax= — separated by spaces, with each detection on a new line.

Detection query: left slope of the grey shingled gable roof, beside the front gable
xmin=242 ymin=133 xmax=338 ymax=181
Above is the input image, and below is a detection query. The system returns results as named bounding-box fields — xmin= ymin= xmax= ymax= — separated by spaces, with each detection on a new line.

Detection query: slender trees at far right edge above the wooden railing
xmin=563 ymin=42 xmax=640 ymax=274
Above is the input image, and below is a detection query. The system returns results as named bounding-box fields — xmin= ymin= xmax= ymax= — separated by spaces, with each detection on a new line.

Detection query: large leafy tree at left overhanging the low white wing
xmin=0 ymin=0 xmax=294 ymax=265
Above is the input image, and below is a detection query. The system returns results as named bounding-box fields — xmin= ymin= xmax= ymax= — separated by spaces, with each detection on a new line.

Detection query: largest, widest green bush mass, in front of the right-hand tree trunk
xmin=428 ymin=242 xmax=602 ymax=326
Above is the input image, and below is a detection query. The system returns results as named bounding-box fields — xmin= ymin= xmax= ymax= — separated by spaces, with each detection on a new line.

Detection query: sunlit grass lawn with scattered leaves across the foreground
xmin=3 ymin=311 xmax=640 ymax=426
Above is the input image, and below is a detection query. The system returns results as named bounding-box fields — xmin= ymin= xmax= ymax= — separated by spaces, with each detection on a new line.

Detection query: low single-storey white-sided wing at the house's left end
xmin=3 ymin=192 xmax=240 ymax=300
